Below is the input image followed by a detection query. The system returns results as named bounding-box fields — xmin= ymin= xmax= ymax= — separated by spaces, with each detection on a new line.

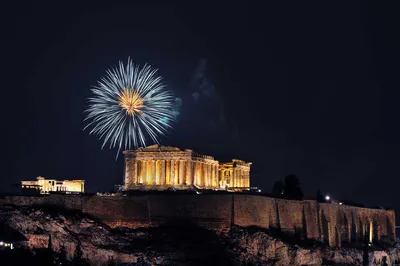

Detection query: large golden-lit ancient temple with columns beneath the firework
xmin=124 ymin=145 xmax=251 ymax=190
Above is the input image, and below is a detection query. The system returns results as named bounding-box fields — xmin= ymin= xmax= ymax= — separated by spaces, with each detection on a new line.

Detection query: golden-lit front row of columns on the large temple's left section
xmin=125 ymin=160 xmax=218 ymax=187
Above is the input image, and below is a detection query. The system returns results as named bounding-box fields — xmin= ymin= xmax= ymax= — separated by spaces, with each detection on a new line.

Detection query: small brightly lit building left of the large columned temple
xmin=21 ymin=176 xmax=85 ymax=194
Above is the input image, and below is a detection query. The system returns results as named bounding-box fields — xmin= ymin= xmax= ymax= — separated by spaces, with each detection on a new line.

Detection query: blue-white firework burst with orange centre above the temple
xmin=85 ymin=59 xmax=175 ymax=156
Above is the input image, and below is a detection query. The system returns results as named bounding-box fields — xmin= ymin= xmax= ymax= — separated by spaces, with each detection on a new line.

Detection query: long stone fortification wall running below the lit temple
xmin=0 ymin=193 xmax=396 ymax=246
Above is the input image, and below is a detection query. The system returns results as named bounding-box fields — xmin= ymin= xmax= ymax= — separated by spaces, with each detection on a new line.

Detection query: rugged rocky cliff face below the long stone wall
xmin=0 ymin=206 xmax=400 ymax=265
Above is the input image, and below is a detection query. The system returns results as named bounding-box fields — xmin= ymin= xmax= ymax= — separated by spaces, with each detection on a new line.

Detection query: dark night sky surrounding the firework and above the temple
xmin=0 ymin=1 xmax=400 ymax=214
